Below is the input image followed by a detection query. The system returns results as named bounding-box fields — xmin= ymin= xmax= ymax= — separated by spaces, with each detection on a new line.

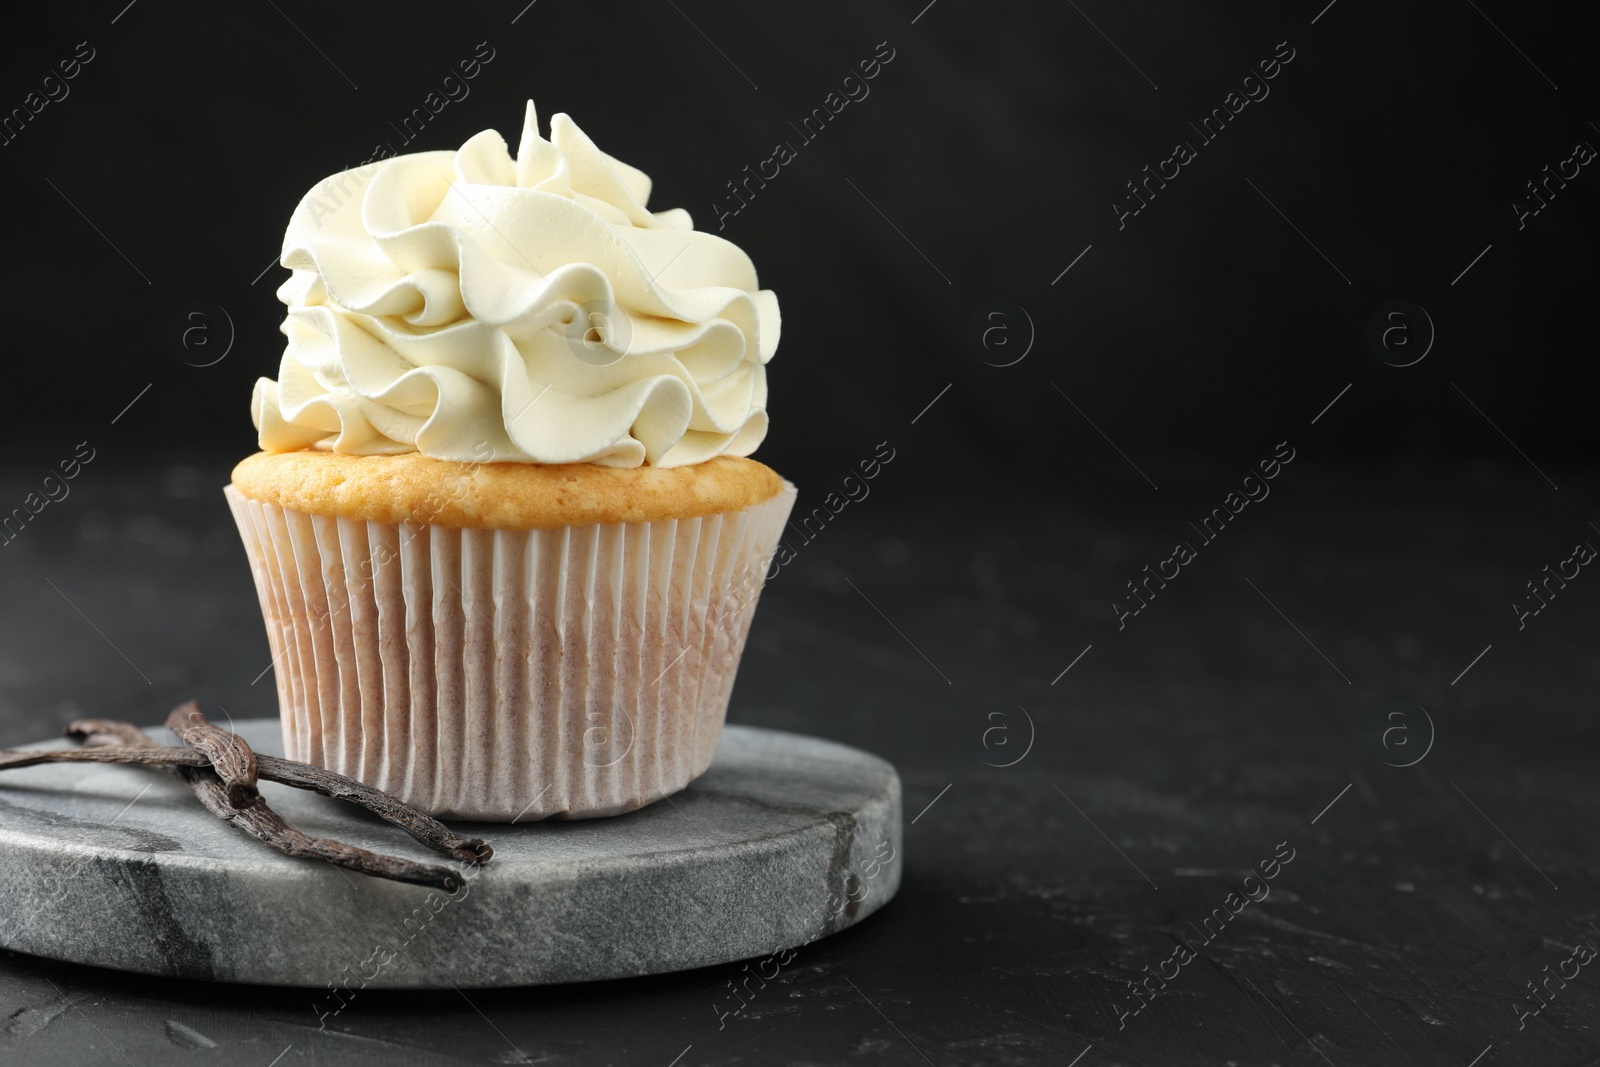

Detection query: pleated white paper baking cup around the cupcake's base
xmin=224 ymin=482 xmax=795 ymax=821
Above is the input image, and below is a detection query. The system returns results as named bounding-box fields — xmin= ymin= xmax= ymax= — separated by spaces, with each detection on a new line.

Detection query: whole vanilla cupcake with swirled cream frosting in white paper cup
xmin=224 ymin=102 xmax=795 ymax=821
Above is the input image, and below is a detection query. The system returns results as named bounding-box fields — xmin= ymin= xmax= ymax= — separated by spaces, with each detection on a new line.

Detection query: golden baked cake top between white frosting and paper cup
xmin=234 ymin=451 xmax=784 ymax=530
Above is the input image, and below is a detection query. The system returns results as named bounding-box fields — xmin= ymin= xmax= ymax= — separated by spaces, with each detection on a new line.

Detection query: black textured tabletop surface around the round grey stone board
xmin=0 ymin=438 xmax=1600 ymax=1067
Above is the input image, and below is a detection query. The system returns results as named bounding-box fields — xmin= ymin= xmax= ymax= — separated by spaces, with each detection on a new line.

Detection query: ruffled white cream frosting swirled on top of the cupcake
xmin=251 ymin=101 xmax=779 ymax=467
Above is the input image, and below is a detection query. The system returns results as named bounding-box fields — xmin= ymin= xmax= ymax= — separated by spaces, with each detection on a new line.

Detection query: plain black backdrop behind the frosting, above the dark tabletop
xmin=0 ymin=0 xmax=1600 ymax=488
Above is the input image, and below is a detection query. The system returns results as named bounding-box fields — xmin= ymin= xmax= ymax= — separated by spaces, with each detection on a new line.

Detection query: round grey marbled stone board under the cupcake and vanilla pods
xmin=0 ymin=720 xmax=904 ymax=991
